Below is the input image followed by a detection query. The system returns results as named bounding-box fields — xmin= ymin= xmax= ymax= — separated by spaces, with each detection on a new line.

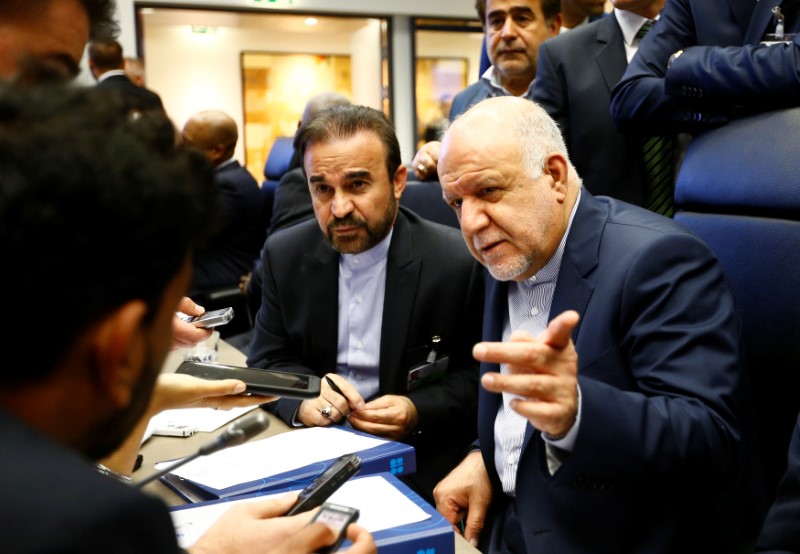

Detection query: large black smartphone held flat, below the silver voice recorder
xmin=175 ymin=362 xmax=320 ymax=399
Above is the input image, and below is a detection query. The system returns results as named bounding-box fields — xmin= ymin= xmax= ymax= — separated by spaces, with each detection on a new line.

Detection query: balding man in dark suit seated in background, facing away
xmin=181 ymin=110 xmax=266 ymax=298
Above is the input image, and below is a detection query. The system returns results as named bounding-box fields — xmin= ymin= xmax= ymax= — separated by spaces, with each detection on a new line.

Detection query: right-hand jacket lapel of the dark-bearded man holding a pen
xmin=379 ymin=210 xmax=422 ymax=393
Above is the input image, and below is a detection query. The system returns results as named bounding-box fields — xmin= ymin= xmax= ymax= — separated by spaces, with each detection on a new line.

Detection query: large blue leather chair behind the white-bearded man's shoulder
xmin=675 ymin=108 xmax=800 ymax=502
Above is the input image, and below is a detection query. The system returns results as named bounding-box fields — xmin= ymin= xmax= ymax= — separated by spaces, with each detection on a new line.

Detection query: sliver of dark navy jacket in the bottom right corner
xmin=756 ymin=410 xmax=800 ymax=553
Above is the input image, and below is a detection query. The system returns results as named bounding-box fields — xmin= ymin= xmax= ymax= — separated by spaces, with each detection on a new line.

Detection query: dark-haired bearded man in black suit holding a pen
xmin=247 ymin=106 xmax=483 ymax=497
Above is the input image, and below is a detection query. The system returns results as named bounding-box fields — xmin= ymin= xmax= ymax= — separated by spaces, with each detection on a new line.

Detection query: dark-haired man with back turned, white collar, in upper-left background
xmin=89 ymin=40 xmax=164 ymax=110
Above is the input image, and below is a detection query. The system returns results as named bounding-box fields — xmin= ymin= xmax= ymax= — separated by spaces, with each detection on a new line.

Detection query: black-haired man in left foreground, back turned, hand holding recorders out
xmin=0 ymin=83 xmax=375 ymax=554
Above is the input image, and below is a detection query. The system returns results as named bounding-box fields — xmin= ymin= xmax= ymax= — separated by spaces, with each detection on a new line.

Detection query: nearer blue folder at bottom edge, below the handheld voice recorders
xmin=170 ymin=472 xmax=455 ymax=554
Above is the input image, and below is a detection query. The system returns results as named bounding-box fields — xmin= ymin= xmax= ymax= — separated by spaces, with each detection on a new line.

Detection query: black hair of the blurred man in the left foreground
xmin=0 ymin=86 xmax=218 ymax=383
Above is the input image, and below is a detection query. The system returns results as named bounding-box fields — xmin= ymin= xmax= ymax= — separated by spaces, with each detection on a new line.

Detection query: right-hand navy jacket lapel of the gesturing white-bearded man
xmin=522 ymin=189 xmax=608 ymax=444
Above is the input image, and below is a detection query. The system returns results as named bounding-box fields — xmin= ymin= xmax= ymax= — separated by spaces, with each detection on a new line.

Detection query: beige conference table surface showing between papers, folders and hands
xmin=133 ymin=340 xmax=479 ymax=554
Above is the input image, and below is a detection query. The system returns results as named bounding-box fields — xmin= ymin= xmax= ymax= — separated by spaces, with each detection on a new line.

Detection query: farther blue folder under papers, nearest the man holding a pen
xmin=161 ymin=427 xmax=417 ymax=503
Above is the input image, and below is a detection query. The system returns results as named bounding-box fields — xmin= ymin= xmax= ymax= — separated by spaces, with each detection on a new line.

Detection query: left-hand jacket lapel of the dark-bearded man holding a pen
xmin=303 ymin=238 xmax=339 ymax=371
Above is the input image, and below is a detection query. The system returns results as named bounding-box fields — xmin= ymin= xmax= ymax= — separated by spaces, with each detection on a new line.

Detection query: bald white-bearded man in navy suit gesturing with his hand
xmin=435 ymin=98 xmax=755 ymax=553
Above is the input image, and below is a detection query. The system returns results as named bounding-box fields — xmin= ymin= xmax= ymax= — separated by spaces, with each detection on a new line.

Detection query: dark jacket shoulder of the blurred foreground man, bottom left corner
xmin=0 ymin=410 xmax=182 ymax=554
